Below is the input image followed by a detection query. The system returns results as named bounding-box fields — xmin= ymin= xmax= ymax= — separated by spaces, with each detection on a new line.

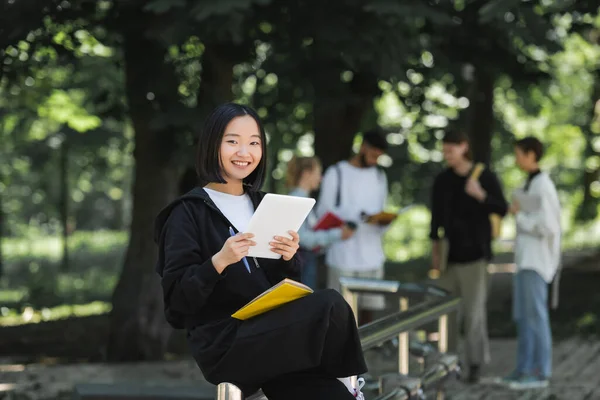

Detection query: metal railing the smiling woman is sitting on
xmin=217 ymin=278 xmax=460 ymax=400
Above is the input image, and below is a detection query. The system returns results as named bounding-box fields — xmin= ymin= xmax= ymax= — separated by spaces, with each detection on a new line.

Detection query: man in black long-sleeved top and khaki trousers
xmin=430 ymin=131 xmax=508 ymax=383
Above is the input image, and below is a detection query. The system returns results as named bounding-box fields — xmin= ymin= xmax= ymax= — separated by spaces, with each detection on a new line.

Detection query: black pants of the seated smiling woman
xmin=211 ymin=289 xmax=367 ymax=400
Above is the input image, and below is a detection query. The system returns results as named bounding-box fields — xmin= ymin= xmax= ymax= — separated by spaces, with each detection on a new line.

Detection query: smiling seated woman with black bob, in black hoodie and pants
xmin=155 ymin=103 xmax=367 ymax=400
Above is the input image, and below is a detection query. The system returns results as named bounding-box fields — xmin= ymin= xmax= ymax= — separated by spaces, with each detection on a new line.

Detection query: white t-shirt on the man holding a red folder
xmin=317 ymin=161 xmax=388 ymax=271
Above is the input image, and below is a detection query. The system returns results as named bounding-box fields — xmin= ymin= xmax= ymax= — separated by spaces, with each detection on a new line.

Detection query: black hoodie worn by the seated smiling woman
xmin=154 ymin=187 xmax=300 ymax=372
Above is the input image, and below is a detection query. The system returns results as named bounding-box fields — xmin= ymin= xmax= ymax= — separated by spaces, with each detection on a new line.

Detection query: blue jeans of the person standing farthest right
xmin=513 ymin=269 xmax=552 ymax=378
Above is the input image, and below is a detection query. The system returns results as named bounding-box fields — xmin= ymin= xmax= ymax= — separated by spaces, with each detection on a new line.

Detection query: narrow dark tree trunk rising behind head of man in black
xmin=467 ymin=67 xmax=494 ymax=165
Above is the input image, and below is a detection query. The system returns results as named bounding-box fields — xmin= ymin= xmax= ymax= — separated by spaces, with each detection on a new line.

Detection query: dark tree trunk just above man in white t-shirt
xmin=313 ymin=73 xmax=378 ymax=169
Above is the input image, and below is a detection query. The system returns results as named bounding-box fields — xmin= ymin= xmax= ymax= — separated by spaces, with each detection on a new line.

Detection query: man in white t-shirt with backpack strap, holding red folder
xmin=316 ymin=131 xmax=388 ymax=324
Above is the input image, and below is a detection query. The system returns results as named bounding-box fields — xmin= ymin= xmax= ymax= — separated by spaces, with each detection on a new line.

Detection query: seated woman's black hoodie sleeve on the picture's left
xmin=161 ymin=204 xmax=225 ymax=314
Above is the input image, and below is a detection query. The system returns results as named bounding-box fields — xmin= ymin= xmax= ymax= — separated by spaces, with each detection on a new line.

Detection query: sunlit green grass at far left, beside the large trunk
xmin=0 ymin=231 xmax=127 ymax=311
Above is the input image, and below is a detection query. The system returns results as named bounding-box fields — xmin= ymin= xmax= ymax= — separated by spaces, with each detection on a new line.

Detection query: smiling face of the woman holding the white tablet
xmin=219 ymin=115 xmax=262 ymax=182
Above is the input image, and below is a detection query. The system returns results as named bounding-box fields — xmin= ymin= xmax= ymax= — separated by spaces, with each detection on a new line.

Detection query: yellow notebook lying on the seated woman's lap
xmin=231 ymin=278 xmax=313 ymax=320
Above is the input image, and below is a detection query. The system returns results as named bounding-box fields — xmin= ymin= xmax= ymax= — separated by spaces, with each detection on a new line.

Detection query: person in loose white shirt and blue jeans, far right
xmin=503 ymin=137 xmax=561 ymax=389
